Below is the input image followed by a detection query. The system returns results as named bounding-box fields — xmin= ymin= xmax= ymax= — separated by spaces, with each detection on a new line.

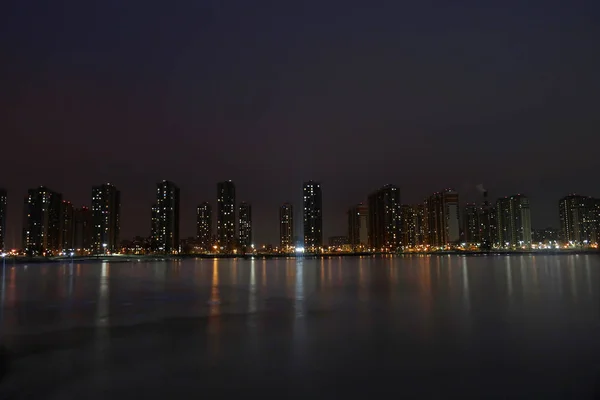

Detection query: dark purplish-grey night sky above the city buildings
xmin=0 ymin=0 xmax=600 ymax=246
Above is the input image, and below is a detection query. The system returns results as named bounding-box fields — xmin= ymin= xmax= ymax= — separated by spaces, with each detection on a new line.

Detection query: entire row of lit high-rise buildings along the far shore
xmin=0 ymin=181 xmax=600 ymax=256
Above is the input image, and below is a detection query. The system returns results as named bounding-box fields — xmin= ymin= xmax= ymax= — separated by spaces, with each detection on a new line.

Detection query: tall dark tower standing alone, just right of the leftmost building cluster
xmin=152 ymin=181 xmax=179 ymax=254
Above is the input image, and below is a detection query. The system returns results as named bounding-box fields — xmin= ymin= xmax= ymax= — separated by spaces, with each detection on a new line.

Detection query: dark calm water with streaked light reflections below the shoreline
xmin=0 ymin=255 xmax=600 ymax=399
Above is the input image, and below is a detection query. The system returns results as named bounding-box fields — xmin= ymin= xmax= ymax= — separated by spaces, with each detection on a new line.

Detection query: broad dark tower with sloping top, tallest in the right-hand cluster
xmin=369 ymin=185 xmax=401 ymax=251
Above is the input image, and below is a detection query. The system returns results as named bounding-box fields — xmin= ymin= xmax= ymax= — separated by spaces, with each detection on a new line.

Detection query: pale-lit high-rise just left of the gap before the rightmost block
xmin=496 ymin=194 xmax=531 ymax=248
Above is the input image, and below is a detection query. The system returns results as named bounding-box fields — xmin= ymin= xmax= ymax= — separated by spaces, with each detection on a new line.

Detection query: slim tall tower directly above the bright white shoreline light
xmin=302 ymin=181 xmax=323 ymax=252
